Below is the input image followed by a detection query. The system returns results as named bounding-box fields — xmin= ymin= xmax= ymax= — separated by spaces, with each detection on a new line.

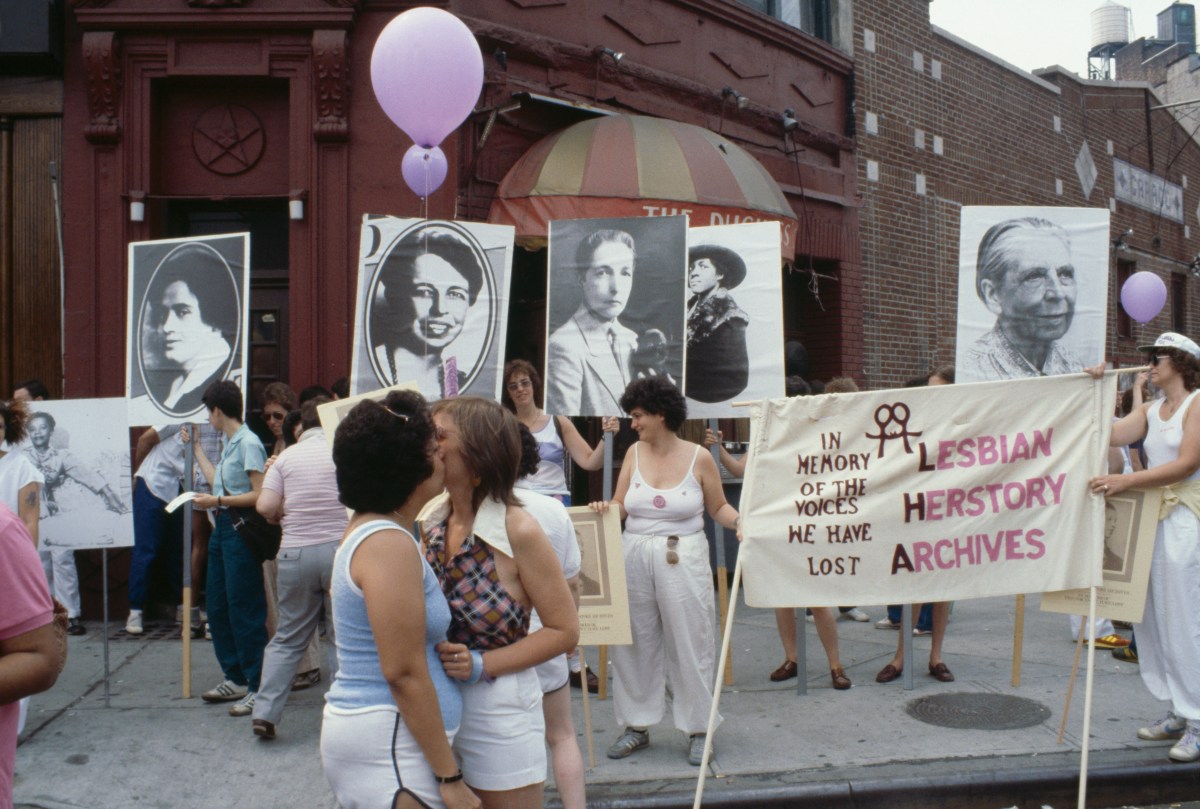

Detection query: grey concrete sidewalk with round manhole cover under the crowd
xmin=14 ymin=585 xmax=1200 ymax=809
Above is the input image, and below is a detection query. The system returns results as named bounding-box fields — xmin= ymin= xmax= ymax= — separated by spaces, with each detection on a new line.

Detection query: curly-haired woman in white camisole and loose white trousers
xmin=592 ymin=377 xmax=738 ymax=766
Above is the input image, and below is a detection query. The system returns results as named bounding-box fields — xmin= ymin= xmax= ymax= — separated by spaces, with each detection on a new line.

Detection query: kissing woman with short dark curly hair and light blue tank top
xmin=320 ymin=391 xmax=480 ymax=809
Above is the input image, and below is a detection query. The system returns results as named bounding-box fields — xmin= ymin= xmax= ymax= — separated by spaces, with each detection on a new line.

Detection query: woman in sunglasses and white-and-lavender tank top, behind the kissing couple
xmin=503 ymin=360 xmax=618 ymax=505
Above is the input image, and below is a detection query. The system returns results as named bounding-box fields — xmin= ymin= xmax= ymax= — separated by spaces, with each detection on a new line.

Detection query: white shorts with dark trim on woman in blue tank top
xmin=320 ymin=705 xmax=456 ymax=809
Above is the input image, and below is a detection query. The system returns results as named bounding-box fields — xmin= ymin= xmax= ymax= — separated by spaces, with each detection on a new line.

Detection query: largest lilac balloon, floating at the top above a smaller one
xmin=371 ymin=7 xmax=484 ymax=149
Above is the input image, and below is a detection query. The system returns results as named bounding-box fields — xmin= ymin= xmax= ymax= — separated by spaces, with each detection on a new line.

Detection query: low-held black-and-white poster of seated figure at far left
xmin=13 ymin=398 xmax=133 ymax=550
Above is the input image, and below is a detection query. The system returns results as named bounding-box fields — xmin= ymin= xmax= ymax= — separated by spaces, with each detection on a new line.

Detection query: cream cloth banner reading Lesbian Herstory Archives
xmin=740 ymin=374 xmax=1116 ymax=607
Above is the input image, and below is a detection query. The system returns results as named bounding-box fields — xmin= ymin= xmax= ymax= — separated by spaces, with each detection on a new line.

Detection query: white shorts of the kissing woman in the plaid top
xmin=454 ymin=669 xmax=546 ymax=791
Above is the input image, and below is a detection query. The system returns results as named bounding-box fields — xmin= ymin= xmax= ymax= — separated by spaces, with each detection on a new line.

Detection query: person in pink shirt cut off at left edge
xmin=0 ymin=503 xmax=67 ymax=809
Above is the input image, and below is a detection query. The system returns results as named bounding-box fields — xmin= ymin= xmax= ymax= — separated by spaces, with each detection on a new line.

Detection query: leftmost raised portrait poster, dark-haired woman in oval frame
xmin=125 ymin=233 xmax=250 ymax=426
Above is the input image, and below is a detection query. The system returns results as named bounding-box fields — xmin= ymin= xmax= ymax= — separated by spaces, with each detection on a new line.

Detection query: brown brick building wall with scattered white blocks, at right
xmin=842 ymin=0 xmax=1200 ymax=388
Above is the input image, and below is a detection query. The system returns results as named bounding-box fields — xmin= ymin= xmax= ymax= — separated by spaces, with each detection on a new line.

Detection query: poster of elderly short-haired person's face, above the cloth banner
xmin=955 ymin=206 xmax=1109 ymax=382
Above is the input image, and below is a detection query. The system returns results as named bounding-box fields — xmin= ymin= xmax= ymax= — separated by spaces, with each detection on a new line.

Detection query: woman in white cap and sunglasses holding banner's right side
xmin=1087 ymin=331 xmax=1200 ymax=761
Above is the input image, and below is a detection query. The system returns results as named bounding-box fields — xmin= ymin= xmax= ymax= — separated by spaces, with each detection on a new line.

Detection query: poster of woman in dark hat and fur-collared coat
xmin=684 ymin=222 xmax=785 ymax=419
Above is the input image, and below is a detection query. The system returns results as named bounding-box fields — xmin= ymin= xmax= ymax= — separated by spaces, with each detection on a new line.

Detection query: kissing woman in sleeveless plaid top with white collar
xmin=420 ymin=396 xmax=580 ymax=808
